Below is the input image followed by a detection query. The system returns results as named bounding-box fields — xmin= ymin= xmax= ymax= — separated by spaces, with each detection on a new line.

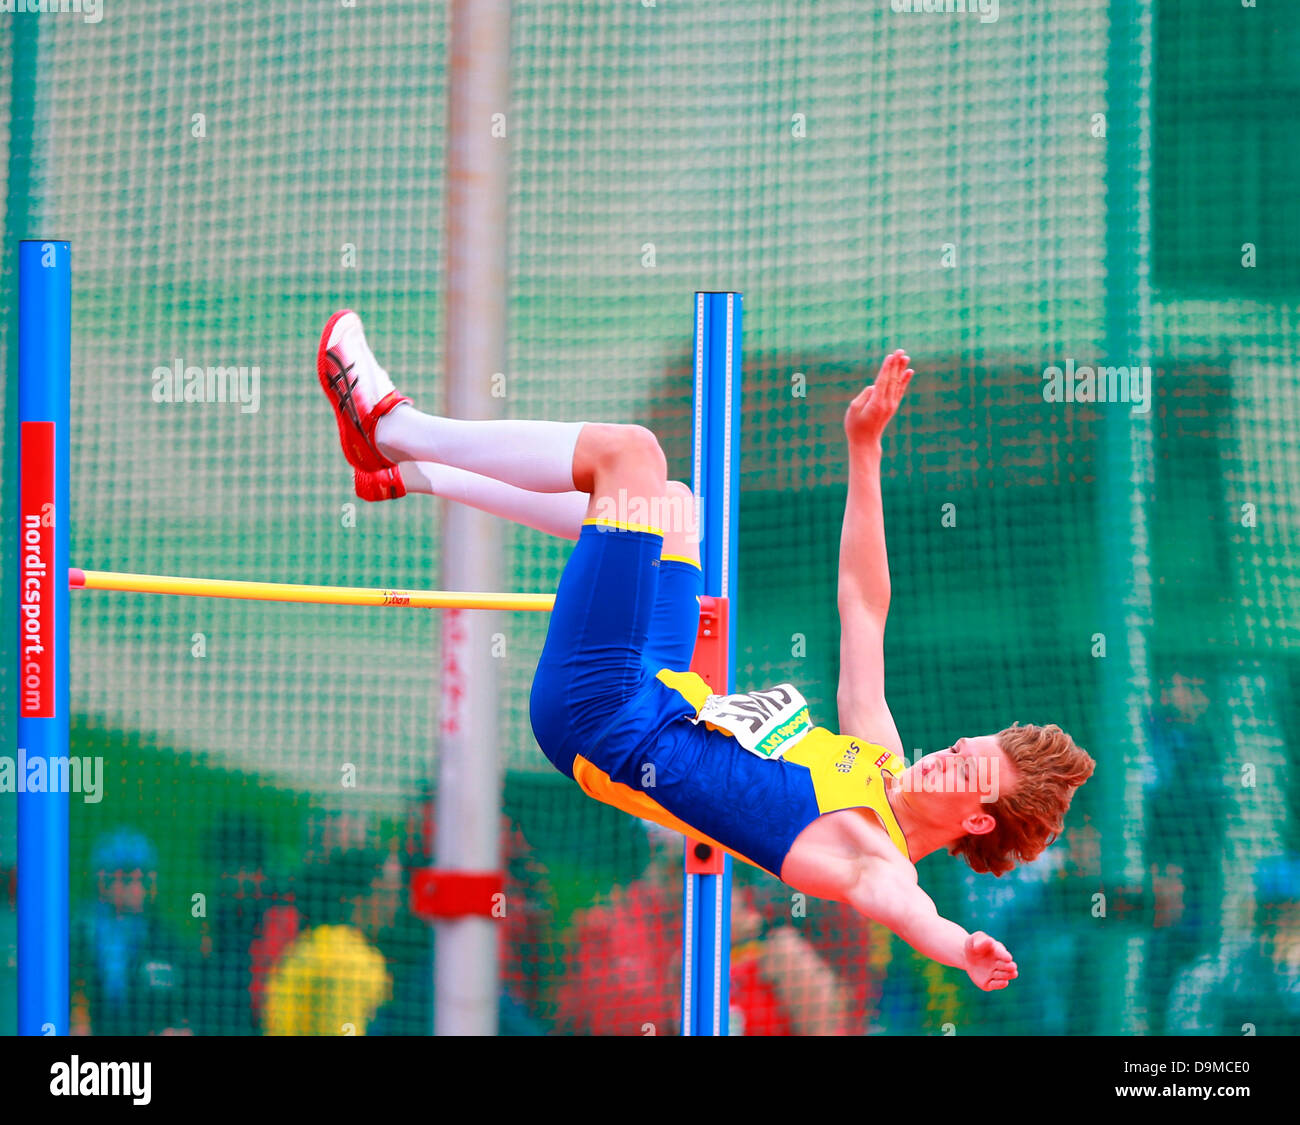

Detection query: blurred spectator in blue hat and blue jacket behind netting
xmin=72 ymin=828 xmax=194 ymax=1035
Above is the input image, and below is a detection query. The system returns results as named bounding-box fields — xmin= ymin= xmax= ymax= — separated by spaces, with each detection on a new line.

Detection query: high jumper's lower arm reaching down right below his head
xmin=846 ymin=862 xmax=1019 ymax=992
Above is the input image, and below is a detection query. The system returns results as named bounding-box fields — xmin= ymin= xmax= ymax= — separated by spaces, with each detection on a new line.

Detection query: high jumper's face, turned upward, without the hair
xmin=901 ymin=735 xmax=1015 ymax=834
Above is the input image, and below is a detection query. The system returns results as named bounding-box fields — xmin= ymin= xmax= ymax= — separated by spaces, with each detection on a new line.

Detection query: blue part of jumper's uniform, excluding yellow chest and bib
xmin=529 ymin=523 xmax=820 ymax=877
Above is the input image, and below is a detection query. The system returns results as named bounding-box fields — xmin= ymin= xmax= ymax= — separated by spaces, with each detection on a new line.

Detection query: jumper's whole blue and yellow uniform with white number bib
xmin=530 ymin=524 xmax=910 ymax=878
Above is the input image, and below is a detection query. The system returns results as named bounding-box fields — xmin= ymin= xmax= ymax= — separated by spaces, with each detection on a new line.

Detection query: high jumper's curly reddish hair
xmin=946 ymin=723 xmax=1097 ymax=875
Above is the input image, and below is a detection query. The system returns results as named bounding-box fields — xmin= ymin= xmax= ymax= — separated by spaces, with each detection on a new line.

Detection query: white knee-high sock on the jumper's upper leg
xmin=374 ymin=403 xmax=582 ymax=492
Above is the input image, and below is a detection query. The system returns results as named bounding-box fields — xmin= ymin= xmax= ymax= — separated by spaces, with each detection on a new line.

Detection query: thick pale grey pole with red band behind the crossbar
xmin=434 ymin=0 xmax=510 ymax=1035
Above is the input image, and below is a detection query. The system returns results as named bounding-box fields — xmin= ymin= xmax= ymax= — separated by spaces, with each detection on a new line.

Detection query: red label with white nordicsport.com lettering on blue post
xmin=18 ymin=421 xmax=55 ymax=719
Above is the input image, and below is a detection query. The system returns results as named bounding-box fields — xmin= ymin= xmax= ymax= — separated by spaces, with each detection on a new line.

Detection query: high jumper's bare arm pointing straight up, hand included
xmin=837 ymin=351 xmax=914 ymax=756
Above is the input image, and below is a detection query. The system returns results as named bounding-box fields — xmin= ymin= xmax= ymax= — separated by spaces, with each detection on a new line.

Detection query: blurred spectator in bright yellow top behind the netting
xmin=263 ymin=848 xmax=393 ymax=1035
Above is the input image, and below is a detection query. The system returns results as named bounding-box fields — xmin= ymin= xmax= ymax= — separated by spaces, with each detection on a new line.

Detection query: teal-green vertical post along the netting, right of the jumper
xmin=1095 ymin=0 xmax=1156 ymax=1035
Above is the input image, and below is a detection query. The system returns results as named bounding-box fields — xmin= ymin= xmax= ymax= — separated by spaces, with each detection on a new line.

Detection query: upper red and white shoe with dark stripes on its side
xmin=316 ymin=308 xmax=411 ymax=470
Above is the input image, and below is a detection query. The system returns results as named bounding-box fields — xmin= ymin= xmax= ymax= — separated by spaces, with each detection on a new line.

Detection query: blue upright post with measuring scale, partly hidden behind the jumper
xmin=681 ymin=293 xmax=741 ymax=1035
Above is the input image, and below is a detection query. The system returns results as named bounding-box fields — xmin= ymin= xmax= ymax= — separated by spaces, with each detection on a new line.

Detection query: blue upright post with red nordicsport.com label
xmin=14 ymin=241 xmax=72 ymax=1035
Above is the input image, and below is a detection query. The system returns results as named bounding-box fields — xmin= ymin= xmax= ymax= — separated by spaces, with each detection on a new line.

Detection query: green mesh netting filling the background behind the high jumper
xmin=0 ymin=0 xmax=1300 ymax=1034
